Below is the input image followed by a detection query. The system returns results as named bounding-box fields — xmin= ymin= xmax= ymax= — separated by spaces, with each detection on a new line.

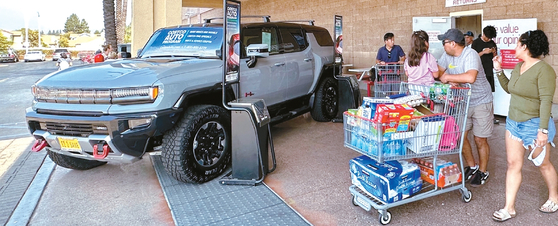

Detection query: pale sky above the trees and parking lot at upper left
xmin=0 ymin=0 xmax=132 ymax=32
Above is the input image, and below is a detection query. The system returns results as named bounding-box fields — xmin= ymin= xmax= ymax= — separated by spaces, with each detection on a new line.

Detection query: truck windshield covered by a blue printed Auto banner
xmin=141 ymin=27 xmax=223 ymax=58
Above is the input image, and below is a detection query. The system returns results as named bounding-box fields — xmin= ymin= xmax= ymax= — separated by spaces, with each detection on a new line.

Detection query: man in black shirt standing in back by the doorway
xmin=471 ymin=25 xmax=500 ymax=124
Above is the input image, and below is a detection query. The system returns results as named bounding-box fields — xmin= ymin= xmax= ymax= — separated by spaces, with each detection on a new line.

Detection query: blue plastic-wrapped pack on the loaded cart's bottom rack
xmin=349 ymin=155 xmax=422 ymax=203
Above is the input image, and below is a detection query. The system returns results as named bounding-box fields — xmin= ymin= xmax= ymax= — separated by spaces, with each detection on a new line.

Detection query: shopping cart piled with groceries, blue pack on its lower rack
xmin=344 ymin=82 xmax=472 ymax=224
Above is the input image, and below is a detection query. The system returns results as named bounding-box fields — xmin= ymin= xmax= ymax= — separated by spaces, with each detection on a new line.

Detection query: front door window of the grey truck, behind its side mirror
xmin=242 ymin=27 xmax=279 ymax=54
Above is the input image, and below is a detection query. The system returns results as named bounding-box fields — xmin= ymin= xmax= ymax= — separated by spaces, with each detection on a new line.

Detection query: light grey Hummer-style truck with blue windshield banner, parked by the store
xmin=26 ymin=17 xmax=346 ymax=183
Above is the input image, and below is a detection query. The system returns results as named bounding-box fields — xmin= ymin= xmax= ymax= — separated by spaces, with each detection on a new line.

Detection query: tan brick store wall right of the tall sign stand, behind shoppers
xmin=242 ymin=0 xmax=558 ymax=103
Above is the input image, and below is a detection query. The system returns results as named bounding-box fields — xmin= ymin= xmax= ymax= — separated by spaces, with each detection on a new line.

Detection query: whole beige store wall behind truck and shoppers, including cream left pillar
xmin=132 ymin=0 xmax=558 ymax=103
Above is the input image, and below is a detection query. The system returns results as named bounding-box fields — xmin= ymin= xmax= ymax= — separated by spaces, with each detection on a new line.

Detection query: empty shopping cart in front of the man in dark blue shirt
xmin=374 ymin=63 xmax=407 ymax=98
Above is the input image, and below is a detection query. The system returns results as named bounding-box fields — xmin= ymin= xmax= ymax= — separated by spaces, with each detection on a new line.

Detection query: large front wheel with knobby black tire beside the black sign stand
xmin=161 ymin=105 xmax=232 ymax=183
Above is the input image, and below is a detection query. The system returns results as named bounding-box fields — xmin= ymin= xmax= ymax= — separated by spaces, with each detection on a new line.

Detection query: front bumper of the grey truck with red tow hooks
xmin=26 ymin=108 xmax=179 ymax=163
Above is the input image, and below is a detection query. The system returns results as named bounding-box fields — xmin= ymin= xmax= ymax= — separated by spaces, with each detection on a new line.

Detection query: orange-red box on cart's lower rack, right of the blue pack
xmin=412 ymin=157 xmax=462 ymax=188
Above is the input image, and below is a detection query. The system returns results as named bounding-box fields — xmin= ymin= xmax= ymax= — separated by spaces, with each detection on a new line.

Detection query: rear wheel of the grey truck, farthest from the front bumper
xmin=310 ymin=77 xmax=339 ymax=122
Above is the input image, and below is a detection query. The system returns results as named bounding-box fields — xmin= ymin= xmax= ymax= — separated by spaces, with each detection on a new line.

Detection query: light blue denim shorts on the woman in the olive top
xmin=506 ymin=118 xmax=556 ymax=149
